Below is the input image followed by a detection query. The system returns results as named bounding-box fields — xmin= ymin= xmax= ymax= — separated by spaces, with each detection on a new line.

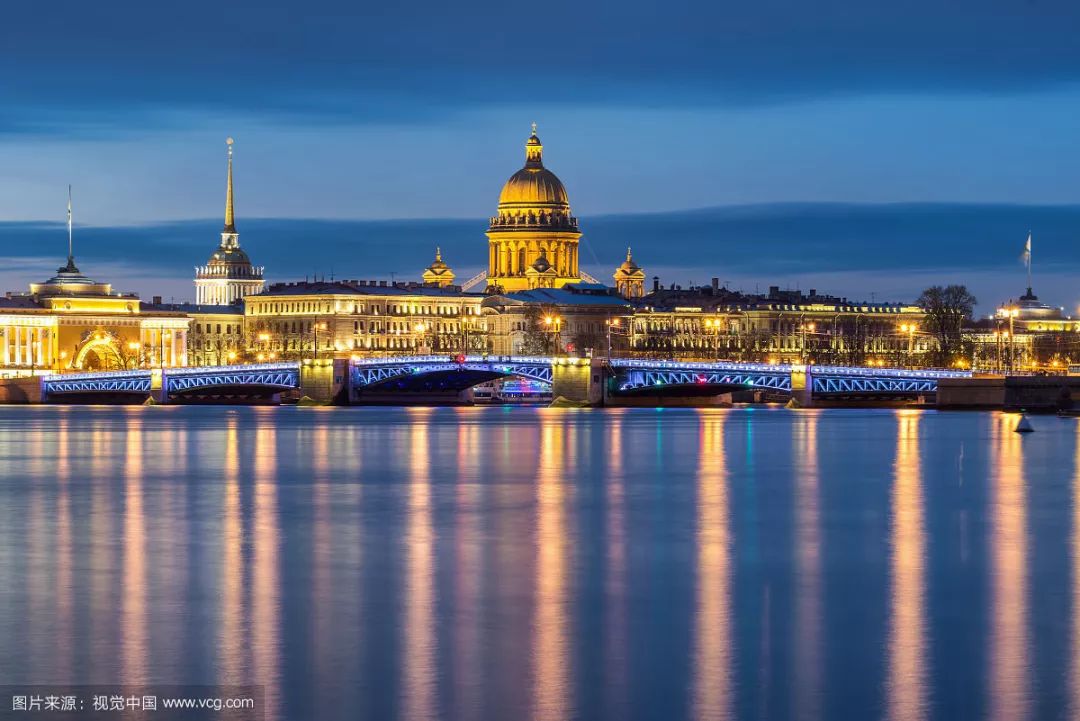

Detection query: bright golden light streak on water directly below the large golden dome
xmin=532 ymin=416 xmax=571 ymax=721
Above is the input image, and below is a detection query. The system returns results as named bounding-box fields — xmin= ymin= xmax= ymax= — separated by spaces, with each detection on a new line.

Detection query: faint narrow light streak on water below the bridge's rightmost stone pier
xmin=792 ymin=410 xmax=821 ymax=719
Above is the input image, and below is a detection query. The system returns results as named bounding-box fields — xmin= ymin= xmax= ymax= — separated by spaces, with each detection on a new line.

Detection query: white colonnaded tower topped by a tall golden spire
xmin=195 ymin=138 xmax=264 ymax=305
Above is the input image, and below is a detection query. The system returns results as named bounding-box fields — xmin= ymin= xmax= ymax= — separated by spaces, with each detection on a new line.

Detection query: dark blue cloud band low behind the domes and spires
xmin=0 ymin=203 xmax=1080 ymax=311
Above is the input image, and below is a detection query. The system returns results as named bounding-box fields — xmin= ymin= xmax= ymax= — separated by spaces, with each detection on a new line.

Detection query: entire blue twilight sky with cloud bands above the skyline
xmin=0 ymin=0 xmax=1080 ymax=311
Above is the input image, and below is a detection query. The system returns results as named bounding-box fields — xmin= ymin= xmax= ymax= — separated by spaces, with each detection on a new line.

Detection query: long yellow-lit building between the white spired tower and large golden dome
xmin=244 ymin=281 xmax=487 ymax=361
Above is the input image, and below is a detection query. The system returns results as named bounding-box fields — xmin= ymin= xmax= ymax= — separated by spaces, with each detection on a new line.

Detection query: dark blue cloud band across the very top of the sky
xmin=6 ymin=0 xmax=1080 ymax=133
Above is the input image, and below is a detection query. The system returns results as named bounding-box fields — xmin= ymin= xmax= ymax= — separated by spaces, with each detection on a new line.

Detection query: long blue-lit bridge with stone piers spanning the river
xmin=41 ymin=355 xmax=971 ymax=405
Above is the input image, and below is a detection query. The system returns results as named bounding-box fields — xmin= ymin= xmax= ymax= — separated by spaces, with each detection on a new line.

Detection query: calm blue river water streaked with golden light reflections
xmin=0 ymin=407 xmax=1080 ymax=721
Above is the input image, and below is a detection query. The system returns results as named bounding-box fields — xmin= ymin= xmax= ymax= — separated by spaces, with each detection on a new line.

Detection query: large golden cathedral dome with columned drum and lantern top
xmin=487 ymin=123 xmax=581 ymax=293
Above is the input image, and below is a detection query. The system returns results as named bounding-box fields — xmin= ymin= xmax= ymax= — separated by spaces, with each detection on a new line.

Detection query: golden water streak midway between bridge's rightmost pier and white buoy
xmin=887 ymin=411 xmax=927 ymax=721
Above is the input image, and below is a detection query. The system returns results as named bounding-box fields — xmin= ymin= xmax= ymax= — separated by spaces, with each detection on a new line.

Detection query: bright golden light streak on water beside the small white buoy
xmin=988 ymin=414 xmax=1029 ymax=721
